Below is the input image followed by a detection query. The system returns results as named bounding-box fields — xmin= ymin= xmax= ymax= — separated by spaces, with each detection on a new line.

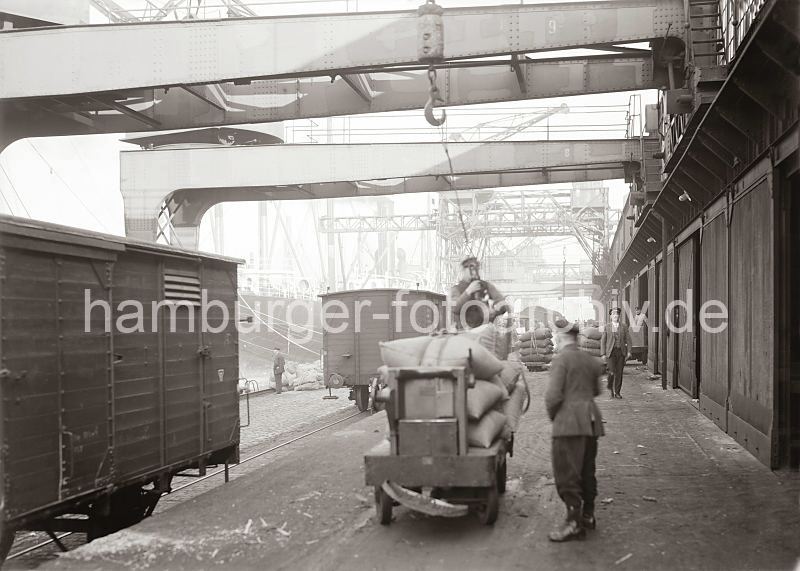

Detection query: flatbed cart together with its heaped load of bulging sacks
xmin=364 ymin=334 xmax=529 ymax=524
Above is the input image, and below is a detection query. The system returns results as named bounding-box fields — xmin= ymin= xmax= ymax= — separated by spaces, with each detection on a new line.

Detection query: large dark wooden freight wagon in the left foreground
xmin=0 ymin=216 xmax=239 ymax=562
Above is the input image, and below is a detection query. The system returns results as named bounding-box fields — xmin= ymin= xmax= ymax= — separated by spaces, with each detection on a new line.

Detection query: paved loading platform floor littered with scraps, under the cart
xmin=45 ymin=366 xmax=800 ymax=571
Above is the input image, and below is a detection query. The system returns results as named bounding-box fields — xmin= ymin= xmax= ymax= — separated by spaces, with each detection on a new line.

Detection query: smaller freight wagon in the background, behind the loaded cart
xmin=320 ymin=288 xmax=447 ymax=411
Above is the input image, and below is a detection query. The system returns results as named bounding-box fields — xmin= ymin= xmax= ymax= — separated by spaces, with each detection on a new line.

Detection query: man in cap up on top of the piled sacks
xmin=448 ymin=256 xmax=509 ymax=329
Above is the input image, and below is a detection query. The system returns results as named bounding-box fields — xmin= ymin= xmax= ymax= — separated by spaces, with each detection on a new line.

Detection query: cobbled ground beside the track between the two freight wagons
xmin=239 ymin=389 xmax=358 ymax=452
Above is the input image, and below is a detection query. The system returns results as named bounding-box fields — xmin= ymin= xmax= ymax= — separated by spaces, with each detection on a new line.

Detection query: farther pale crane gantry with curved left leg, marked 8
xmin=120 ymin=139 xmax=641 ymax=247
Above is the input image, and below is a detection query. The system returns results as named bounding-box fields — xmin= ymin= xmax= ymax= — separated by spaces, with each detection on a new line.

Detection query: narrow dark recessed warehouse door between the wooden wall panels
xmin=675 ymin=235 xmax=699 ymax=398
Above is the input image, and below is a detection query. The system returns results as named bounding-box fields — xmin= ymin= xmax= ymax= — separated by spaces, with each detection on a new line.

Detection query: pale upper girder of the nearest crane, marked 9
xmin=0 ymin=0 xmax=685 ymax=99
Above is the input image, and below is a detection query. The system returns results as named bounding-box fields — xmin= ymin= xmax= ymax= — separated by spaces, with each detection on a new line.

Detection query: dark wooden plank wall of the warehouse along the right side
xmin=622 ymin=158 xmax=790 ymax=467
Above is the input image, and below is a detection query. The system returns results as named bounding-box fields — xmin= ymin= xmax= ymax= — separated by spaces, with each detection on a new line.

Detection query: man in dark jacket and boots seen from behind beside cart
xmin=544 ymin=322 xmax=603 ymax=541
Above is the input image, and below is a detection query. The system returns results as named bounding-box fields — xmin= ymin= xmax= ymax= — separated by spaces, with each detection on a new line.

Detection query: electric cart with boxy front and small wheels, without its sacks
xmin=364 ymin=367 xmax=513 ymax=525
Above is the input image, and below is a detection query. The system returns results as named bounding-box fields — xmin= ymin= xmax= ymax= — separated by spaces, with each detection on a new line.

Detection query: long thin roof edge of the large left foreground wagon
xmin=0 ymin=214 xmax=244 ymax=264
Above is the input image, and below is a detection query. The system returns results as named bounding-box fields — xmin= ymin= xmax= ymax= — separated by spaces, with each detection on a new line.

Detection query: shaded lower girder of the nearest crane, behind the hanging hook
xmin=0 ymin=54 xmax=663 ymax=148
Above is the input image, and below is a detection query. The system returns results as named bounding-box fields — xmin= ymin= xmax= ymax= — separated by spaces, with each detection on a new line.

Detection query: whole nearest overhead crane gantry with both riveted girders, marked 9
xmin=0 ymin=0 xmax=684 ymax=150
